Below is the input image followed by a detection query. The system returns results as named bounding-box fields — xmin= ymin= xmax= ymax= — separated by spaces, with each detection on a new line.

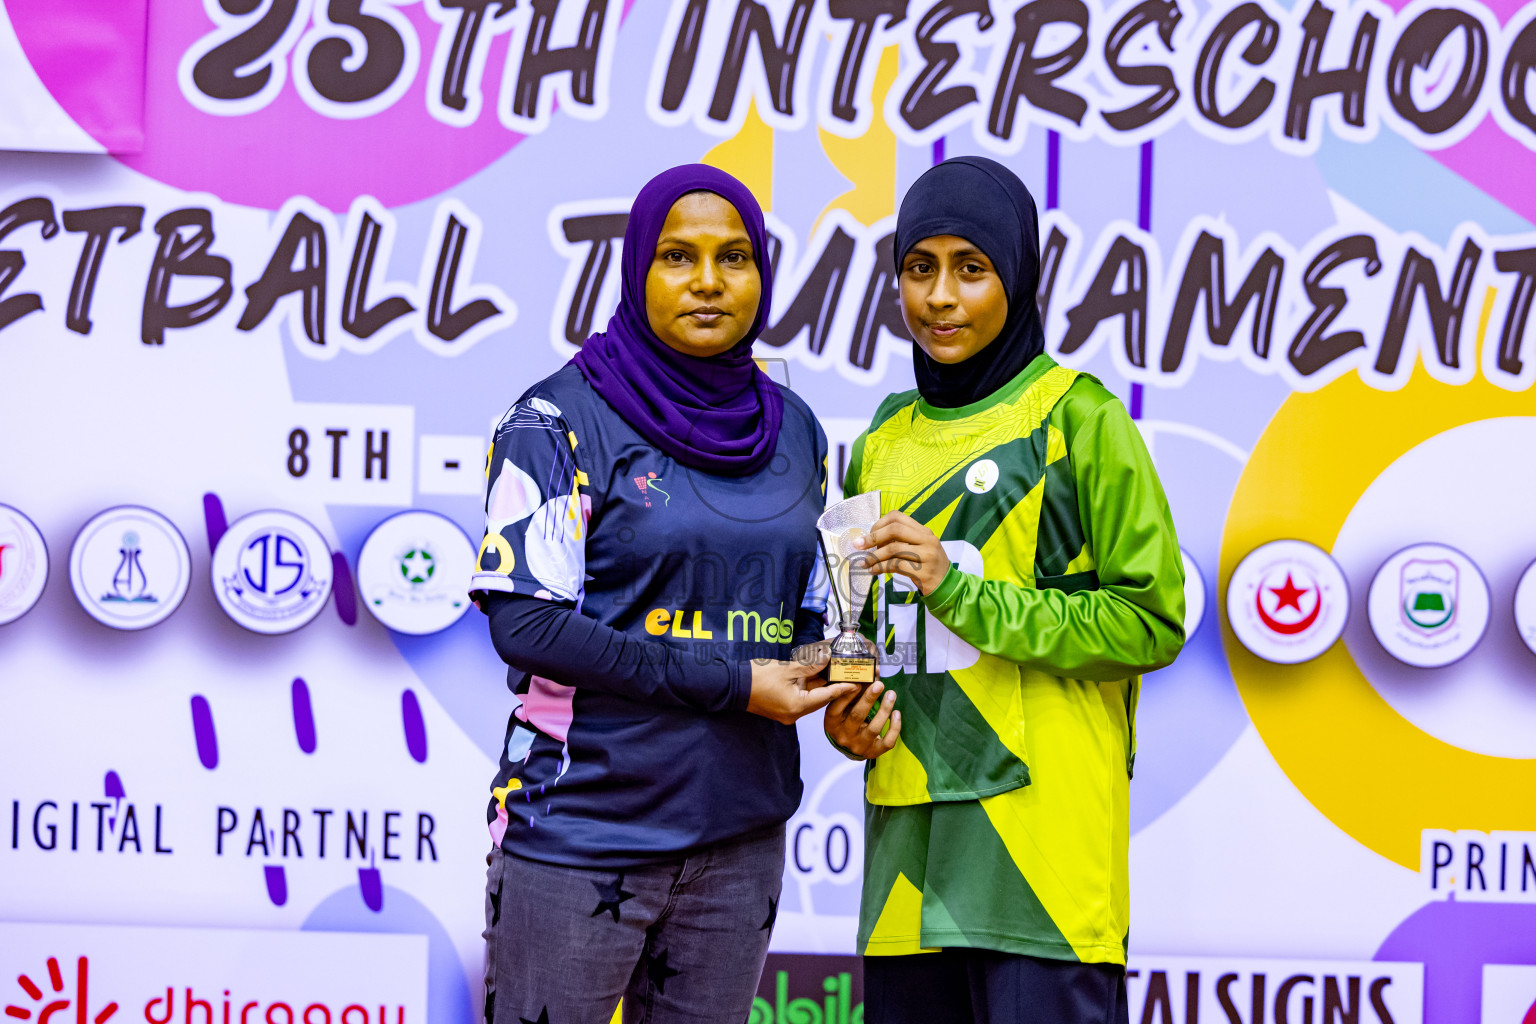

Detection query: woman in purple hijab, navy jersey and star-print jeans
xmin=472 ymin=164 xmax=852 ymax=1024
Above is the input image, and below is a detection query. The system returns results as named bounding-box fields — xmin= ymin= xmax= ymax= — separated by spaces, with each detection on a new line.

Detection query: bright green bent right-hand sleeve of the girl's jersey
xmin=923 ymin=402 xmax=1184 ymax=682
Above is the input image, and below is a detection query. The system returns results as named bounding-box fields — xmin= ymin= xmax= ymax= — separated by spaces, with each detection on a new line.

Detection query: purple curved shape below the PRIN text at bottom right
xmin=1375 ymin=900 xmax=1536 ymax=1024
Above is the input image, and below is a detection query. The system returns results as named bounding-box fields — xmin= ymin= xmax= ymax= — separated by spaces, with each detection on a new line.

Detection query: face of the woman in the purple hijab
xmin=645 ymin=192 xmax=762 ymax=356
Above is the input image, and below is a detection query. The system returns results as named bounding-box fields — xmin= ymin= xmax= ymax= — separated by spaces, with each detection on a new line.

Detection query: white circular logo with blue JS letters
xmin=214 ymin=511 xmax=332 ymax=634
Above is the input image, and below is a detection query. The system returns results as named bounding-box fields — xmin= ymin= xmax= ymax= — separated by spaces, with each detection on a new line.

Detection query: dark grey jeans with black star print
xmin=485 ymin=826 xmax=785 ymax=1024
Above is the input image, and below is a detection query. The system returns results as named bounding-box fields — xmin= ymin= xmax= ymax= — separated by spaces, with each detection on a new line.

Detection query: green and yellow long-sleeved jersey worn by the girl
xmin=845 ymin=356 xmax=1184 ymax=963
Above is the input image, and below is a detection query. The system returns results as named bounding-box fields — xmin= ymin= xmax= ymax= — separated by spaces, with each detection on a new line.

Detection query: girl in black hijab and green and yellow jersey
xmin=826 ymin=157 xmax=1184 ymax=1024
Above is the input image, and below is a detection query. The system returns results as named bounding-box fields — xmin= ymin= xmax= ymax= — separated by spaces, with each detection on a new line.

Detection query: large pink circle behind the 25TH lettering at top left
xmin=11 ymin=0 xmax=524 ymax=210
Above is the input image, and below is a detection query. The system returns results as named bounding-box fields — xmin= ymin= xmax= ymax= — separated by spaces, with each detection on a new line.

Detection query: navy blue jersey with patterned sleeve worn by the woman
xmin=470 ymin=364 xmax=826 ymax=866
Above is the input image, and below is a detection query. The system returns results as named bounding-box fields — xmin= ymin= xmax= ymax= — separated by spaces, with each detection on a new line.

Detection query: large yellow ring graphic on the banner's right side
xmin=1218 ymin=367 xmax=1536 ymax=870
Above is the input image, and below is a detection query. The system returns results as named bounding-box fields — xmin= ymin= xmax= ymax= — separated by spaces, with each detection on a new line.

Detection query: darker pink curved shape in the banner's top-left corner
xmin=6 ymin=0 xmax=146 ymax=154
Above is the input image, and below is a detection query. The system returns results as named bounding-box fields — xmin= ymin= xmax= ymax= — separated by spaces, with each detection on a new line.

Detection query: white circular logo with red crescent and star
xmin=1227 ymin=540 xmax=1349 ymax=665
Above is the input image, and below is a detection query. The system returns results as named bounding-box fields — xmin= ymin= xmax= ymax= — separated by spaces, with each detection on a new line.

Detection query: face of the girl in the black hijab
xmin=900 ymin=235 xmax=1008 ymax=364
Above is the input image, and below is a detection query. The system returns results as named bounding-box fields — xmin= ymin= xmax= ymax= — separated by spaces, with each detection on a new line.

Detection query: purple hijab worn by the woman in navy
xmin=576 ymin=164 xmax=783 ymax=476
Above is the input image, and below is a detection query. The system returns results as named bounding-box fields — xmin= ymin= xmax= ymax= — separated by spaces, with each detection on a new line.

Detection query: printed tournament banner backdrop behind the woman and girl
xmin=0 ymin=0 xmax=1536 ymax=1024
